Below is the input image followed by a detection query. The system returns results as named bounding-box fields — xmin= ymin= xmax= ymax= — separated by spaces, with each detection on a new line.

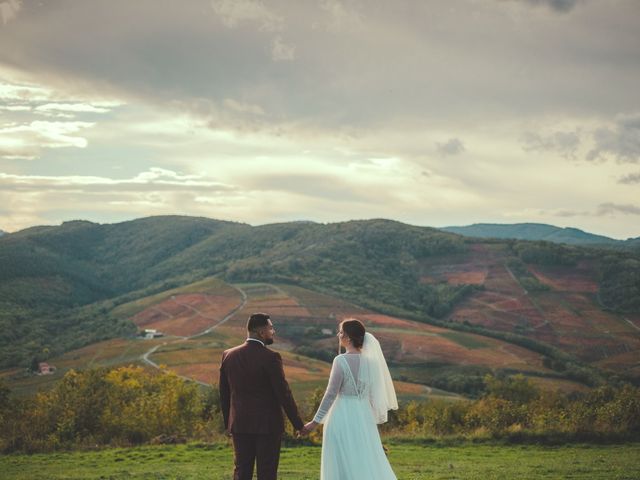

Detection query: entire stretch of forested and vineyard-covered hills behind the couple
xmin=0 ymin=216 xmax=640 ymax=394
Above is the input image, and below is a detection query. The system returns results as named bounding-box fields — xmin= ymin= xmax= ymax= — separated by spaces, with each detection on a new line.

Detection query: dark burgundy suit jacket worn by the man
xmin=219 ymin=340 xmax=304 ymax=434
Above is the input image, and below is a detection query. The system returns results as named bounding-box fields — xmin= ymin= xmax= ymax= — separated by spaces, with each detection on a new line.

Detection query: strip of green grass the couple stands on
xmin=0 ymin=441 xmax=640 ymax=480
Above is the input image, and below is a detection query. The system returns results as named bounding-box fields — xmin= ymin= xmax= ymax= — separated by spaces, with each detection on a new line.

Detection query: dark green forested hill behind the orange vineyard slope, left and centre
xmin=0 ymin=216 xmax=464 ymax=366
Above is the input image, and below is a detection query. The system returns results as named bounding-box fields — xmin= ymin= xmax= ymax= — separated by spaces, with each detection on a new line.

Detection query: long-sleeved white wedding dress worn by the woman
xmin=314 ymin=353 xmax=398 ymax=480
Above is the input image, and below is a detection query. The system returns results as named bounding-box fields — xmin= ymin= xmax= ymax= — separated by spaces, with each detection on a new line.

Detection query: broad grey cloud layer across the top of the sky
xmin=0 ymin=0 xmax=638 ymax=131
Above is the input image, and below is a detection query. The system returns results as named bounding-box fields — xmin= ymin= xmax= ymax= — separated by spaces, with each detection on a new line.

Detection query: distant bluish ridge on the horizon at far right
xmin=440 ymin=223 xmax=640 ymax=246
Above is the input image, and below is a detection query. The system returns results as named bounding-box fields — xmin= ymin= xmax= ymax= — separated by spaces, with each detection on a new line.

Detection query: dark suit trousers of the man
xmin=232 ymin=433 xmax=282 ymax=480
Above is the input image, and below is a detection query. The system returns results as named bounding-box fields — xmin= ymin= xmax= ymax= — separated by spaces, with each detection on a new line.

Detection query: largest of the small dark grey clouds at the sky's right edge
xmin=587 ymin=113 xmax=640 ymax=163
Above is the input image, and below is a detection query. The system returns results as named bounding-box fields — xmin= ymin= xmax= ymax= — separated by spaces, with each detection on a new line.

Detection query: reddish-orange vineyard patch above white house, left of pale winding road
xmin=133 ymin=293 xmax=240 ymax=336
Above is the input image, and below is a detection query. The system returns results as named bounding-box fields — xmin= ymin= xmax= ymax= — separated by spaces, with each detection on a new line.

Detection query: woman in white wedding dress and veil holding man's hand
xmin=303 ymin=319 xmax=398 ymax=480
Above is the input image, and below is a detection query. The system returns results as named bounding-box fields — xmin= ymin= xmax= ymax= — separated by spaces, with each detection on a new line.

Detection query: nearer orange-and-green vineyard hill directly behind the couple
xmin=0 ymin=278 xmax=584 ymax=400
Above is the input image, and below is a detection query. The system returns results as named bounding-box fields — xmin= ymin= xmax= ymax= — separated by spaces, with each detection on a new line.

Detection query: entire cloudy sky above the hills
xmin=0 ymin=0 xmax=640 ymax=239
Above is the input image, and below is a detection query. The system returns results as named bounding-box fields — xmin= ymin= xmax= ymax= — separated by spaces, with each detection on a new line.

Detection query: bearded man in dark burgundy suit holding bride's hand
xmin=219 ymin=313 xmax=304 ymax=480
